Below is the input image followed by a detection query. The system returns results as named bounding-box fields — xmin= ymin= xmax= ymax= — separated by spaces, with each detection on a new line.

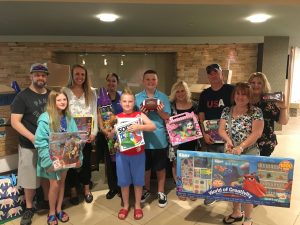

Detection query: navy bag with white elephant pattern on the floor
xmin=0 ymin=173 xmax=25 ymax=224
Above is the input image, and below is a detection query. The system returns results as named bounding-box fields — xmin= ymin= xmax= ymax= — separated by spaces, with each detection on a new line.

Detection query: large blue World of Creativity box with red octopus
xmin=176 ymin=151 xmax=294 ymax=208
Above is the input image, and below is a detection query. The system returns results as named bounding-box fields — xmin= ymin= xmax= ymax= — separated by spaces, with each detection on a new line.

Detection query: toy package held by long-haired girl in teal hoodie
xmin=49 ymin=131 xmax=88 ymax=171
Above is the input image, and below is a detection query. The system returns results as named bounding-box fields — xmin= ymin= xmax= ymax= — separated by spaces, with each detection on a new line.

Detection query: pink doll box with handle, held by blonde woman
xmin=166 ymin=112 xmax=202 ymax=146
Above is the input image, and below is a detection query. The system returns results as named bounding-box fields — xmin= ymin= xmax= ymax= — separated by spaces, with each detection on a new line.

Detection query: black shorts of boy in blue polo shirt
xmin=145 ymin=148 xmax=168 ymax=171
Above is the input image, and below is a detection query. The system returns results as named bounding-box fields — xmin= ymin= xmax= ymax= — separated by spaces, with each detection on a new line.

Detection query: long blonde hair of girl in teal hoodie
xmin=46 ymin=90 xmax=71 ymax=132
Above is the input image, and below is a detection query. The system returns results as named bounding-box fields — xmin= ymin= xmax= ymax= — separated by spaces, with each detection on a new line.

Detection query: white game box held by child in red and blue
xmin=115 ymin=117 xmax=145 ymax=152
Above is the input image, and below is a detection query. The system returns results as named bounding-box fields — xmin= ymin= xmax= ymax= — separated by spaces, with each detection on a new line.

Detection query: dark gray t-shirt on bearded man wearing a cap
xmin=11 ymin=88 xmax=50 ymax=148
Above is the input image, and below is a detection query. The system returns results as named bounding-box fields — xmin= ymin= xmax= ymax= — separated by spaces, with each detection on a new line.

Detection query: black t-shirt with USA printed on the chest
xmin=198 ymin=84 xmax=234 ymax=120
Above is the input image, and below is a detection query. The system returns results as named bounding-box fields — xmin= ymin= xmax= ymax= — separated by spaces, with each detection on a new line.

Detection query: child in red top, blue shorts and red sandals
xmin=116 ymin=89 xmax=156 ymax=220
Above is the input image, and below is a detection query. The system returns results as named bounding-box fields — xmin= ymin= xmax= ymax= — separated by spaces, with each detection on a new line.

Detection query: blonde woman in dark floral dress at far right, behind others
xmin=248 ymin=72 xmax=289 ymax=156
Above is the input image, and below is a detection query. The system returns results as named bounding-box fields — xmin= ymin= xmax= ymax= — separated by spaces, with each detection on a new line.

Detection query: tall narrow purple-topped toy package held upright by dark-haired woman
xmin=97 ymin=88 xmax=117 ymax=159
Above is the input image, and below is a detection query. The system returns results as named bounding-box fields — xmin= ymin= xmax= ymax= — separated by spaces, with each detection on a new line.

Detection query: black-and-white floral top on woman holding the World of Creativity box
xmin=221 ymin=106 xmax=263 ymax=146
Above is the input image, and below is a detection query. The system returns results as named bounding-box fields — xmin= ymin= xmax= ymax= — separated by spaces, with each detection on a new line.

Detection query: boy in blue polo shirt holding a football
xmin=135 ymin=70 xmax=171 ymax=207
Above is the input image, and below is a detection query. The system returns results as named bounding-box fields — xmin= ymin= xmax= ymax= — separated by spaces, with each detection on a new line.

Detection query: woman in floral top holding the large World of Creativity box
xmin=219 ymin=83 xmax=264 ymax=225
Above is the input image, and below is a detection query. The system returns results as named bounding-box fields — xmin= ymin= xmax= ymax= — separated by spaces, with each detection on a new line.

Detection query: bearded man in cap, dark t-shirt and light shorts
xmin=11 ymin=63 xmax=49 ymax=225
